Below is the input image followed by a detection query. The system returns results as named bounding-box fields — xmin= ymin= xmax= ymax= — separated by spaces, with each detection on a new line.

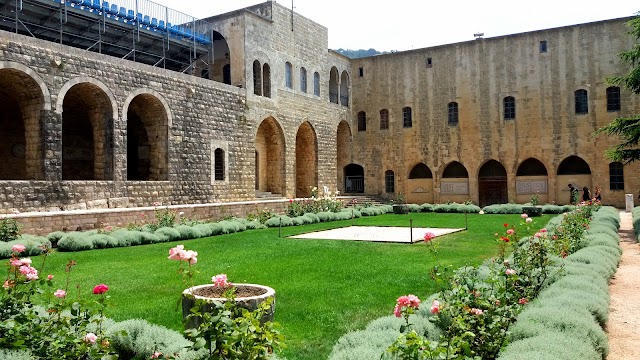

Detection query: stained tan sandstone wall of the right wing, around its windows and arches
xmin=351 ymin=19 xmax=640 ymax=206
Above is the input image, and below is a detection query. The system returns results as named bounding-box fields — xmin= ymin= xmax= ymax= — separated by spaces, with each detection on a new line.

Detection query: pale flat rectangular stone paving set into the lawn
xmin=290 ymin=226 xmax=464 ymax=244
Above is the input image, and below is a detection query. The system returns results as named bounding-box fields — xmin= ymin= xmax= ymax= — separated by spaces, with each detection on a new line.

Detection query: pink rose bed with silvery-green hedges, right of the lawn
xmin=330 ymin=206 xmax=621 ymax=360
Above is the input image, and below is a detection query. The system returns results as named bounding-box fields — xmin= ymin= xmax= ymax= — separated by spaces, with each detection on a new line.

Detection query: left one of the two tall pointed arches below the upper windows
xmin=255 ymin=117 xmax=286 ymax=195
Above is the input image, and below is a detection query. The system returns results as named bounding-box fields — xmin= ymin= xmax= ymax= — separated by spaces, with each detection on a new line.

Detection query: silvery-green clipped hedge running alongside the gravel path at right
xmin=499 ymin=207 xmax=622 ymax=360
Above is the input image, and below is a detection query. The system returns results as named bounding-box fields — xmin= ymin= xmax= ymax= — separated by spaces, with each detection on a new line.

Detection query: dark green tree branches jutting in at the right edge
xmin=594 ymin=12 xmax=640 ymax=164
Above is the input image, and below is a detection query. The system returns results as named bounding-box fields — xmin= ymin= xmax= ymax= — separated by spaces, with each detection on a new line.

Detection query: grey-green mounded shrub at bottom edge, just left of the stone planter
xmin=105 ymin=319 xmax=206 ymax=360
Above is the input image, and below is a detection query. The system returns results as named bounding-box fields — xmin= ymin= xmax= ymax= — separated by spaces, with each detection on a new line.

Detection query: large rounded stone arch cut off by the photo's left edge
xmin=0 ymin=61 xmax=51 ymax=180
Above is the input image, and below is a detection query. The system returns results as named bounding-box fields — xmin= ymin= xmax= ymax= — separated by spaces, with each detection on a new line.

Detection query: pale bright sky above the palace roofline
xmin=156 ymin=0 xmax=640 ymax=51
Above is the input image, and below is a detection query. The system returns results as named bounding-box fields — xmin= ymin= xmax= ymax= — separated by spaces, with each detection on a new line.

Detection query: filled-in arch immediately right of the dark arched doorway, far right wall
xmin=516 ymin=158 xmax=549 ymax=204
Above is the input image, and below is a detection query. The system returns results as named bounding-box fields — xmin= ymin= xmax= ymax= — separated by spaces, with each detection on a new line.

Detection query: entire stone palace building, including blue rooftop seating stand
xmin=0 ymin=0 xmax=640 ymax=213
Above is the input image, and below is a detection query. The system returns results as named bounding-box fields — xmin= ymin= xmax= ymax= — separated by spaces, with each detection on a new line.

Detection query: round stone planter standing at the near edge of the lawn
xmin=182 ymin=284 xmax=276 ymax=328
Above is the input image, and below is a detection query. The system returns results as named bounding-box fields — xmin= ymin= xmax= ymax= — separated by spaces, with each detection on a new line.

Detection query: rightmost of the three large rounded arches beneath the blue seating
xmin=122 ymin=89 xmax=173 ymax=181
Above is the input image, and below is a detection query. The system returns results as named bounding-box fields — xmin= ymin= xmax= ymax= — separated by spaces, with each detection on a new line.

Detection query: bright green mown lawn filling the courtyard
xmin=40 ymin=213 xmax=550 ymax=359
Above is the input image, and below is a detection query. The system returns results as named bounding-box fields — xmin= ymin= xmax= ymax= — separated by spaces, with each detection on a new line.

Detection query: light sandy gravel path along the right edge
xmin=607 ymin=211 xmax=640 ymax=360
